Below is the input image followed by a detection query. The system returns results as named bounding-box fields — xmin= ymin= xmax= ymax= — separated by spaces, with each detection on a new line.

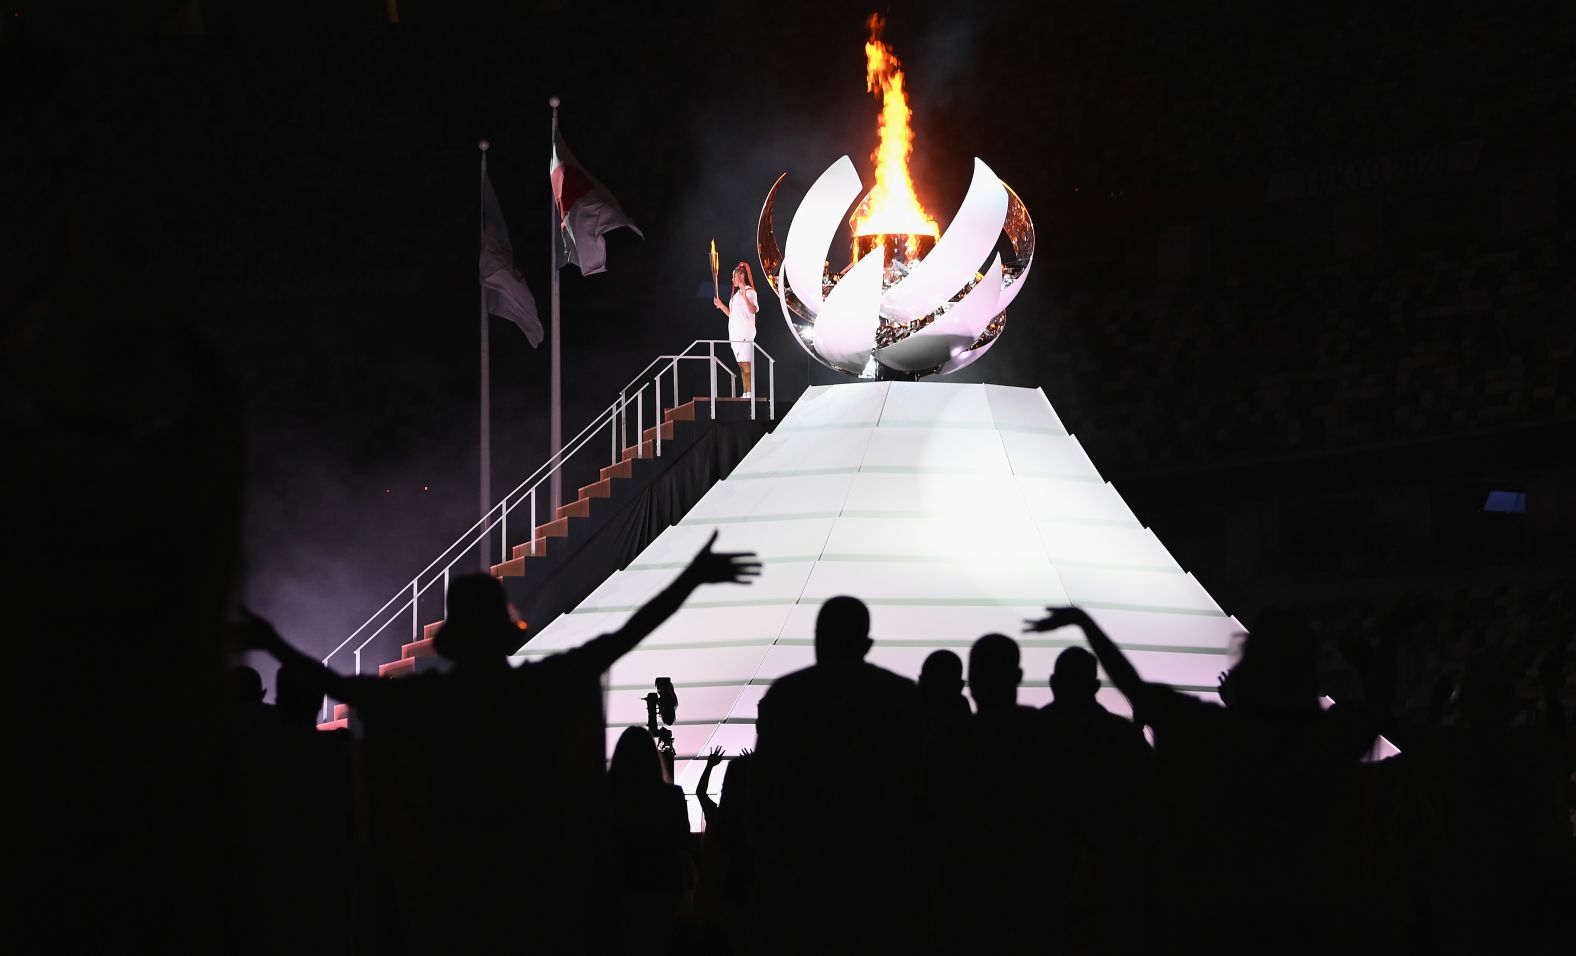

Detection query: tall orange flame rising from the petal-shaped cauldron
xmin=849 ymin=13 xmax=941 ymax=236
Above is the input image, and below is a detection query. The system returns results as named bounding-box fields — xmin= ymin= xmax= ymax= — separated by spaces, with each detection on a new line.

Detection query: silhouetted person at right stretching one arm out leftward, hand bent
xmin=1029 ymin=608 xmax=1376 ymax=951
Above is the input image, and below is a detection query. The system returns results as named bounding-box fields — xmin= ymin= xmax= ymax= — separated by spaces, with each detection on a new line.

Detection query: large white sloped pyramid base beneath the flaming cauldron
xmin=517 ymin=383 xmax=1243 ymax=828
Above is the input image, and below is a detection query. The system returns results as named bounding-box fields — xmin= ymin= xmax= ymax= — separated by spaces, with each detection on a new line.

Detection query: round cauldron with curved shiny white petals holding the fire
xmin=756 ymin=156 xmax=1034 ymax=380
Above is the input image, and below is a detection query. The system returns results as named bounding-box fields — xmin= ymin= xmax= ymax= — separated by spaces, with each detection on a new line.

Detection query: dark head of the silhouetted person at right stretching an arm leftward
xmin=1228 ymin=608 xmax=1319 ymax=713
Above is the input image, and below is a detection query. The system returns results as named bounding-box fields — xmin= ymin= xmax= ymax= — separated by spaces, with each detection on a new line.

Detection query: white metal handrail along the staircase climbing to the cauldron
xmin=323 ymin=339 xmax=777 ymax=717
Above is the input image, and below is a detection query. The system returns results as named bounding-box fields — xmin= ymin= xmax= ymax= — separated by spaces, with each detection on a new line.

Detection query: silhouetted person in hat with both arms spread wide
xmin=252 ymin=534 xmax=760 ymax=951
